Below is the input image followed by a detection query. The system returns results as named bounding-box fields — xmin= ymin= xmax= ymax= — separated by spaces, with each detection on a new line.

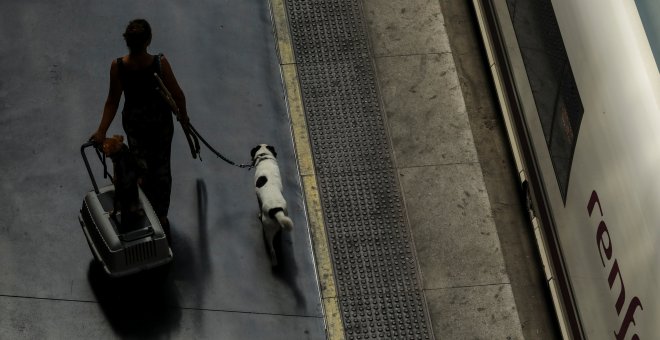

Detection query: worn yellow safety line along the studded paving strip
xmin=270 ymin=0 xmax=345 ymax=340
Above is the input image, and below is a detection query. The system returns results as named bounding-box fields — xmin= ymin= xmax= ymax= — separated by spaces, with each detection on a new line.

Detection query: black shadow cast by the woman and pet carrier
xmin=87 ymin=183 xmax=209 ymax=338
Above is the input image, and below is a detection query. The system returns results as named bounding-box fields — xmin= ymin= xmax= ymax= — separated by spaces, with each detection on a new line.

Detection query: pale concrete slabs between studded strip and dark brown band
xmin=365 ymin=1 xmax=522 ymax=339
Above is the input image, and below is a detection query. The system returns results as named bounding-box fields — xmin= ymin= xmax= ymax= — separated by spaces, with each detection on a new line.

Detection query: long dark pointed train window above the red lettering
xmin=507 ymin=0 xmax=584 ymax=201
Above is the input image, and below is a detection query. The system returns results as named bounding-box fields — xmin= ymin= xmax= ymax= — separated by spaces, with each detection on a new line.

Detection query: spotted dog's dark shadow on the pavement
xmin=260 ymin=224 xmax=305 ymax=308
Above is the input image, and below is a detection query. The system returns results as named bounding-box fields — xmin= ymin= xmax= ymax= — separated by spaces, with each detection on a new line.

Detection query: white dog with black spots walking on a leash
xmin=250 ymin=144 xmax=293 ymax=267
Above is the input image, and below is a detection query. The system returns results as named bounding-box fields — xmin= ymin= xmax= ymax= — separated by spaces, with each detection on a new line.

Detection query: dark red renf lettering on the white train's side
xmin=587 ymin=190 xmax=644 ymax=340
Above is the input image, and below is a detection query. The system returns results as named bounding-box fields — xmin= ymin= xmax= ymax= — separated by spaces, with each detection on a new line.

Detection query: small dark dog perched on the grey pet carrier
xmin=102 ymin=135 xmax=144 ymax=234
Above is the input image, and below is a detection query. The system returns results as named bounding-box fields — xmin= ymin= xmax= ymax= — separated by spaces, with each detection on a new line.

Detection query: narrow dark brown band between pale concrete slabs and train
xmin=440 ymin=0 xmax=561 ymax=339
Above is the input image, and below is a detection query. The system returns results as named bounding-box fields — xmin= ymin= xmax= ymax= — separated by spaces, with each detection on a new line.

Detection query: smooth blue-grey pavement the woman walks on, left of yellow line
xmin=0 ymin=1 xmax=325 ymax=339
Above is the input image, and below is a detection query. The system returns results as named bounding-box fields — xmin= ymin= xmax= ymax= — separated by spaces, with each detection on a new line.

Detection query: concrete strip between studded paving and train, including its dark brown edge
xmin=362 ymin=0 xmax=561 ymax=339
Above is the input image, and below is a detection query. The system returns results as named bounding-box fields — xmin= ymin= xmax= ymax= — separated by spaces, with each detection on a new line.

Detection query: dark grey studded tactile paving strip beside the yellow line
xmin=286 ymin=0 xmax=433 ymax=339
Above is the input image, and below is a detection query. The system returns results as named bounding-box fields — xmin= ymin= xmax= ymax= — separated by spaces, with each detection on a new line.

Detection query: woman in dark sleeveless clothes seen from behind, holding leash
xmin=91 ymin=19 xmax=188 ymax=239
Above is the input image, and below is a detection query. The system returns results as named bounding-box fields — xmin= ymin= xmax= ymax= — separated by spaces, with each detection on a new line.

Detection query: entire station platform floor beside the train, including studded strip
xmin=0 ymin=0 xmax=560 ymax=339
